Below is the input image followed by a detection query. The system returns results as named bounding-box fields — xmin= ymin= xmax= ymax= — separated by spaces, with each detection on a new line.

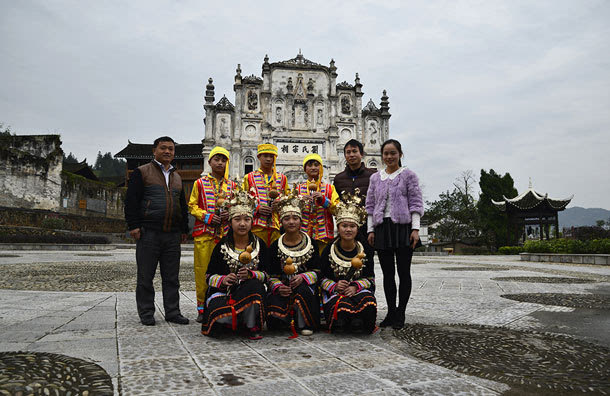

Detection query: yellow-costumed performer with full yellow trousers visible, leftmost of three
xmin=189 ymin=146 xmax=237 ymax=323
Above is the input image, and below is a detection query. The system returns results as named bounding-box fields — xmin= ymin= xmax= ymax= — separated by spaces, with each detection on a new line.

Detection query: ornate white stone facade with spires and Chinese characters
xmin=203 ymin=53 xmax=390 ymax=183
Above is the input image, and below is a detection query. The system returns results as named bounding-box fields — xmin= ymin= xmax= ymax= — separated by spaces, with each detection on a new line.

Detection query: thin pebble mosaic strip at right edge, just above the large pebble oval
xmin=500 ymin=293 xmax=610 ymax=309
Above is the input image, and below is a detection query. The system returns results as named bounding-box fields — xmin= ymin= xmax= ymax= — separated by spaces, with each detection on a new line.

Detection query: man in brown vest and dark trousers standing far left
xmin=125 ymin=136 xmax=189 ymax=326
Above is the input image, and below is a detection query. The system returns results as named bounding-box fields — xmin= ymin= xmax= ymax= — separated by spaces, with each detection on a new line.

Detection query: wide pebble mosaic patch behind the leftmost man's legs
xmin=0 ymin=260 xmax=195 ymax=292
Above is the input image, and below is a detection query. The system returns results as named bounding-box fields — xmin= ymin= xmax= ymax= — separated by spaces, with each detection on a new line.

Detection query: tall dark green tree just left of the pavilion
xmin=477 ymin=169 xmax=517 ymax=249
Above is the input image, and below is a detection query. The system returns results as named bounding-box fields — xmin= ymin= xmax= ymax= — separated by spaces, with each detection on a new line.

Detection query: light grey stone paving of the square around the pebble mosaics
xmin=0 ymin=250 xmax=610 ymax=396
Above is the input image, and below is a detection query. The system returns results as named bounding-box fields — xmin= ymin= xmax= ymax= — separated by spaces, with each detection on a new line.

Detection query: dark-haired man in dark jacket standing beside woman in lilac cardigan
xmin=333 ymin=139 xmax=377 ymax=241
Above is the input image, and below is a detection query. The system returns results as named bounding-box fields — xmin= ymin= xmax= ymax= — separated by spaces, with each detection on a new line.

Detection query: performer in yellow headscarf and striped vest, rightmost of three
xmin=297 ymin=154 xmax=339 ymax=254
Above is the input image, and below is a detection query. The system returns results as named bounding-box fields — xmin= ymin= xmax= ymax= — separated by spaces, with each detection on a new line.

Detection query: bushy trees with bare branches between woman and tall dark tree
xmin=426 ymin=171 xmax=479 ymax=247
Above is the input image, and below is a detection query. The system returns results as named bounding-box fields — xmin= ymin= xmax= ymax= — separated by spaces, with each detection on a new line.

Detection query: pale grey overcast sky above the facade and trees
xmin=0 ymin=0 xmax=610 ymax=209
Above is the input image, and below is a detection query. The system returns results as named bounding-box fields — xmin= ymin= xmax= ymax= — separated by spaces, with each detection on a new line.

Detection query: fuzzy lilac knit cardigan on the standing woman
xmin=366 ymin=169 xmax=424 ymax=226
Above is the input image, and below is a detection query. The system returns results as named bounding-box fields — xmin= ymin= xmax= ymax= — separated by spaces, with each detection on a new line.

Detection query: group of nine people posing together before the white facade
xmin=125 ymin=139 xmax=423 ymax=339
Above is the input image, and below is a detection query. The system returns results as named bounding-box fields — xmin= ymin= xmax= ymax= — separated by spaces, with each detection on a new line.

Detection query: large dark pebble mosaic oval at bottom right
xmin=390 ymin=324 xmax=610 ymax=394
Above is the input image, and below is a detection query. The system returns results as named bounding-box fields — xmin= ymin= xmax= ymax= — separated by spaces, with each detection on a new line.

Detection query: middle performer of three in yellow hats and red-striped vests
xmin=243 ymin=143 xmax=288 ymax=247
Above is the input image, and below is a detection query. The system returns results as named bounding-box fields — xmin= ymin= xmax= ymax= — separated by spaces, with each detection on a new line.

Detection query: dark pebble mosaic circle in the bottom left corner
xmin=0 ymin=352 xmax=114 ymax=395
